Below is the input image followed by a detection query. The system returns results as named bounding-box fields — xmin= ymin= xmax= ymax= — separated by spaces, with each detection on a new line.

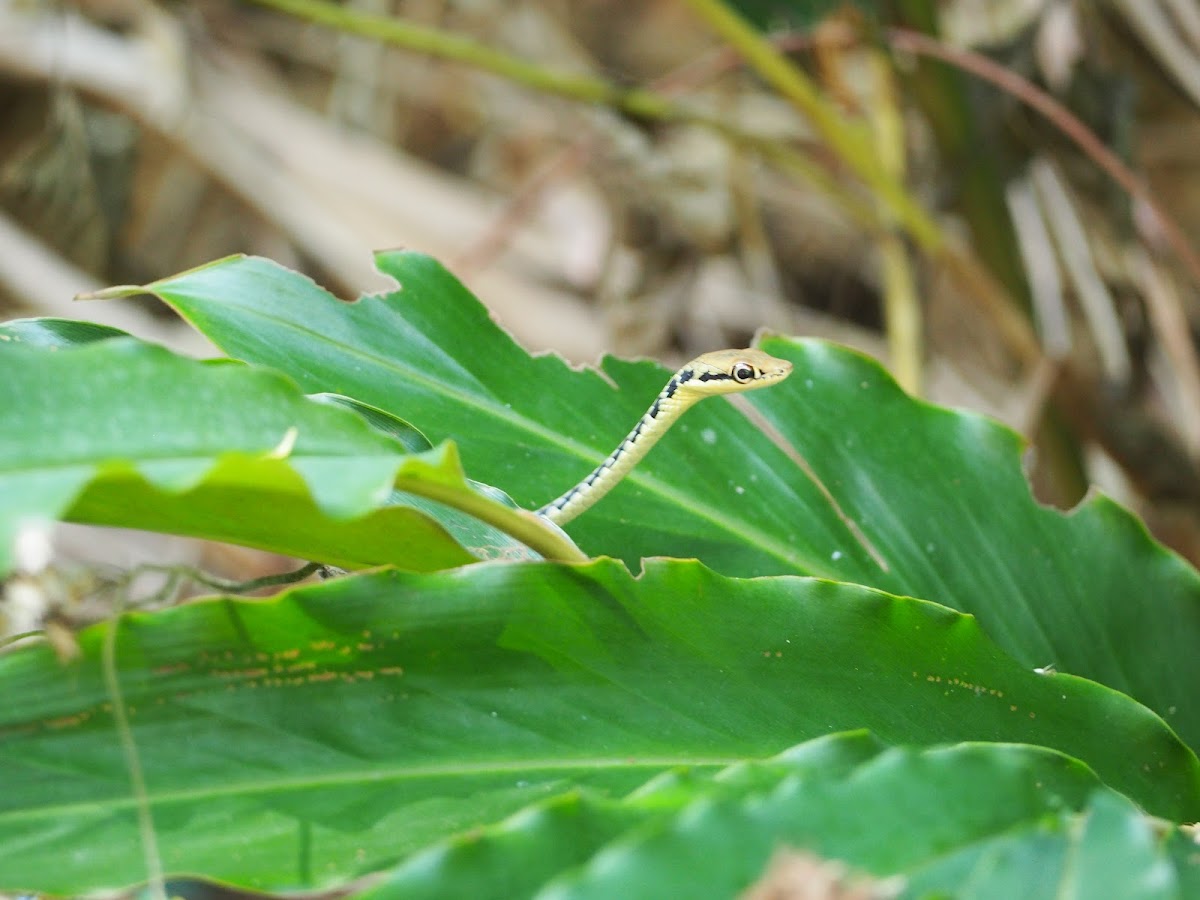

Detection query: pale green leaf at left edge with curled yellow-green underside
xmin=0 ymin=338 xmax=506 ymax=570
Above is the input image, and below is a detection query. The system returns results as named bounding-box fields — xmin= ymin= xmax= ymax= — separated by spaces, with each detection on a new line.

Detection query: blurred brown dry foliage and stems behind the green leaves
xmin=0 ymin=0 xmax=1200 ymax=570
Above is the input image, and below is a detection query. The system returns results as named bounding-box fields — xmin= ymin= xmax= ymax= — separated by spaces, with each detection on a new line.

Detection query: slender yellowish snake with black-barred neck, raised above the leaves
xmin=536 ymin=348 xmax=792 ymax=526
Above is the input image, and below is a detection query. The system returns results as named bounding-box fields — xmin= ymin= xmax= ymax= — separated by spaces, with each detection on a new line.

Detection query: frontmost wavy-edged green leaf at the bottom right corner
xmin=552 ymin=745 xmax=1186 ymax=900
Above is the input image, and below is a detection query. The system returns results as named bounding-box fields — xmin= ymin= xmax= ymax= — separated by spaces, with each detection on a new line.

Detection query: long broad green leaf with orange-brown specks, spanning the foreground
xmin=0 ymin=560 xmax=1200 ymax=893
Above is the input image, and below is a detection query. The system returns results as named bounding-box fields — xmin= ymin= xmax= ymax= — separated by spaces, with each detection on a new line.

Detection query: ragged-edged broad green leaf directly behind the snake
xmin=114 ymin=253 xmax=1200 ymax=746
